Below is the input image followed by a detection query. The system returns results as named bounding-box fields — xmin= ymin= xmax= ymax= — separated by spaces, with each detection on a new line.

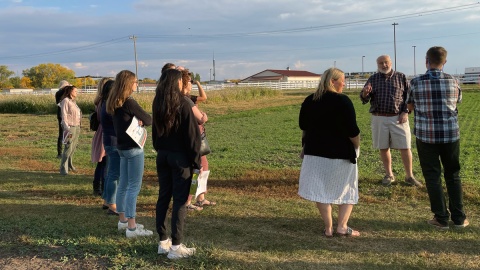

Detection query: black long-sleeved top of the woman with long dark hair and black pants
xmin=152 ymin=98 xmax=201 ymax=169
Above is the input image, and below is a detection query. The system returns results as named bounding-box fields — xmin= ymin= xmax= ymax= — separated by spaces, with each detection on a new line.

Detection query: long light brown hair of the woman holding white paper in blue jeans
xmin=106 ymin=70 xmax=137 ymax=115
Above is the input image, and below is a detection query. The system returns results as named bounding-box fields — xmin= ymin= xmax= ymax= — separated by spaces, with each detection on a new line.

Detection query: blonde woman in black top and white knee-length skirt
xmin=298 ymin=68 xmax=360 ymax=237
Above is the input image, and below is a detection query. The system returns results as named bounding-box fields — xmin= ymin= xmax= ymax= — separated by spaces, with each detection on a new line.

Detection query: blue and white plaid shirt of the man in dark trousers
xmin=407 ymin=69 xmax=462 ymax=143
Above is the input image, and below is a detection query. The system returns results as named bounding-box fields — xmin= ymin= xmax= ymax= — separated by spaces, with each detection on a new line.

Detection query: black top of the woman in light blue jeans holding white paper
xmin=112 ymin=97 xmax=152 ymax=150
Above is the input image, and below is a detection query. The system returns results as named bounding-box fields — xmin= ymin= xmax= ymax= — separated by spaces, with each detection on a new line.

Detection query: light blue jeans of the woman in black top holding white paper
xmin=116 ymin=148 xmax=144 ymax=218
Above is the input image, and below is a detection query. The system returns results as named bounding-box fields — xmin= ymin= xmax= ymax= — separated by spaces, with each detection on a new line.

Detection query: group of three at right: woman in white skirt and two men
xmin=298 ymin=46 xmax=469 ymax=237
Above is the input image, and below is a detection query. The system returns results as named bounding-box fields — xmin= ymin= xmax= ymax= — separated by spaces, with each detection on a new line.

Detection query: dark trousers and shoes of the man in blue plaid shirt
xmin=416 ymin=139 xmax=466 ymax=225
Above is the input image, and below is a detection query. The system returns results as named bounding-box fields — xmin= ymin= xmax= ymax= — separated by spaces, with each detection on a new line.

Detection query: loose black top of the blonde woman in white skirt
xmin=299 ymin=91 xmax=360 ymax=164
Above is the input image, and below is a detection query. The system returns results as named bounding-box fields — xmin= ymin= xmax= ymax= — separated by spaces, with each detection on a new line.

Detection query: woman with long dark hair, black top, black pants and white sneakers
xmin=152 ymin=69 xmax=201 ymax=259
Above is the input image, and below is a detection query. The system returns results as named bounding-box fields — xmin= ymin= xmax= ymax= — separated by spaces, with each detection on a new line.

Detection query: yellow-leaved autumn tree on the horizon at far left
xmin=22 ymin=63 xmax=75 ymax=88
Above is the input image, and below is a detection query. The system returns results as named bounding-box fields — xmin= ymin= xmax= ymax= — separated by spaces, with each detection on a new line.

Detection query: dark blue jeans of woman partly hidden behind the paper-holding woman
xmin=102 ymin=146 xmax=120 ymax=204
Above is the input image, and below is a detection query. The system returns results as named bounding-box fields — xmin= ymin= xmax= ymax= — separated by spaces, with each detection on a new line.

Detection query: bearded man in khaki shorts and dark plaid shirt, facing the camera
xmin=360 ymin=55 xmax=422 ymax=187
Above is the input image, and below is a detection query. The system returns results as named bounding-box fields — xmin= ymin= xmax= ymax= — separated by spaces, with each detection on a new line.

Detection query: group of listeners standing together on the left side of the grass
xmin=56 ymin=63 xmax=216 ymax=259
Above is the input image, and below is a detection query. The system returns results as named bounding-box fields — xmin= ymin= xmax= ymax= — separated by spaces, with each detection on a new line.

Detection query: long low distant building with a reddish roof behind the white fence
xmin=240 ymin=69 xmax=321 ymax=83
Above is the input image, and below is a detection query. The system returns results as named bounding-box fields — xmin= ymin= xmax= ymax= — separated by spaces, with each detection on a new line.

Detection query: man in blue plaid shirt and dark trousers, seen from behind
xmin=407 ymin=47 xmax=469 ymax=229
